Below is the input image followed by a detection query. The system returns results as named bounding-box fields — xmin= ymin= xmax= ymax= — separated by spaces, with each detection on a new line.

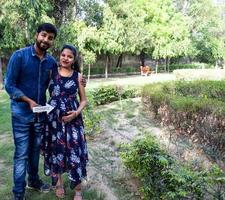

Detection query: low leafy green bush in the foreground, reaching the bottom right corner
xmin=120 ymin=135 xmax=225 ymax=200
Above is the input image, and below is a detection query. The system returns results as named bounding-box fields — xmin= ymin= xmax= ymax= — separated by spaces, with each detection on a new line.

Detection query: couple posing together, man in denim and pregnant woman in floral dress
xmin=5 ymin=23 xmax=88 ymax=200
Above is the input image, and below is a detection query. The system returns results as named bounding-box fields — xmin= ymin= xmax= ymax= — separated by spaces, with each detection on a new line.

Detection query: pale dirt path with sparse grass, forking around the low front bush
xmin=85 ymin=98 xmax=213 ymax=200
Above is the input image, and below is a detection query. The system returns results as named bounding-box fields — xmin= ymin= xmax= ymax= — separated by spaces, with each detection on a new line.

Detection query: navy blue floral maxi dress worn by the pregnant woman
xmin=41 ymin=71 xmax=88 ymax=189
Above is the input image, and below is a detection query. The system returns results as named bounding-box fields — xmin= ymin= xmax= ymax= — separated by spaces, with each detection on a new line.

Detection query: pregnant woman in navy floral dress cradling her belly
xmin=42 ymin=45 xmax=88 ymax=200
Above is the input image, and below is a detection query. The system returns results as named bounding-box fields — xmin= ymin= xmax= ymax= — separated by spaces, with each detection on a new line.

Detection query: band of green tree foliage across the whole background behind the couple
xmin=0 ymin=0 xmax=225 ymax=83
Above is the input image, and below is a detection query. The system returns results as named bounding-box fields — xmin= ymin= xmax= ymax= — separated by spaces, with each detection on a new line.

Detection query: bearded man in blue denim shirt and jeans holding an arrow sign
xmin=5 ymin=23 xmax=57 ymax=200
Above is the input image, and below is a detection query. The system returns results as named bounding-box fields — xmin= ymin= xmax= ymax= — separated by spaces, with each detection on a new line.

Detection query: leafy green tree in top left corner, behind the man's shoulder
xmin=0 ymin=0 xmax=51 ymax=87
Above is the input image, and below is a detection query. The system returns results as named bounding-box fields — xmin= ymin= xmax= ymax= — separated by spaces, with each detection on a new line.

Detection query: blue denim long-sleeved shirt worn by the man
xmin=5 ymin=45 xmax=57 ymax=122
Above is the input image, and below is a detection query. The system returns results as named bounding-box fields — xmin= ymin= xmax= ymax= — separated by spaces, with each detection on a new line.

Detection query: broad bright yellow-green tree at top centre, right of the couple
xmin=108 ymin=0 xmax=190 ymax=72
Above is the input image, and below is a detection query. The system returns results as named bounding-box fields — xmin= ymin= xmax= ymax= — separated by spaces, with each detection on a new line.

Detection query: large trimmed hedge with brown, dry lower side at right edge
xmin=142 ymin=81 xmax=225 ymax=159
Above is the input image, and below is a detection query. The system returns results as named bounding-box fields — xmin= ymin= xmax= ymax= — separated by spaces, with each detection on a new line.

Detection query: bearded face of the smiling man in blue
xmin=35 ymin=31 xmax=55 ymax=51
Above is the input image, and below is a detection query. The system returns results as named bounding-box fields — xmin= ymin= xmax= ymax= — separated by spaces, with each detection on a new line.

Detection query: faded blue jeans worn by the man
xmin=12 ymin=116 xmax=44 ymax=195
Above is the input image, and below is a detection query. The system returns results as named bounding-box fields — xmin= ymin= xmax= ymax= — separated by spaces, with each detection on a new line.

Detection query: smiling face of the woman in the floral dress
xmin=59 ymin=49 xmax=74 ymax=68
